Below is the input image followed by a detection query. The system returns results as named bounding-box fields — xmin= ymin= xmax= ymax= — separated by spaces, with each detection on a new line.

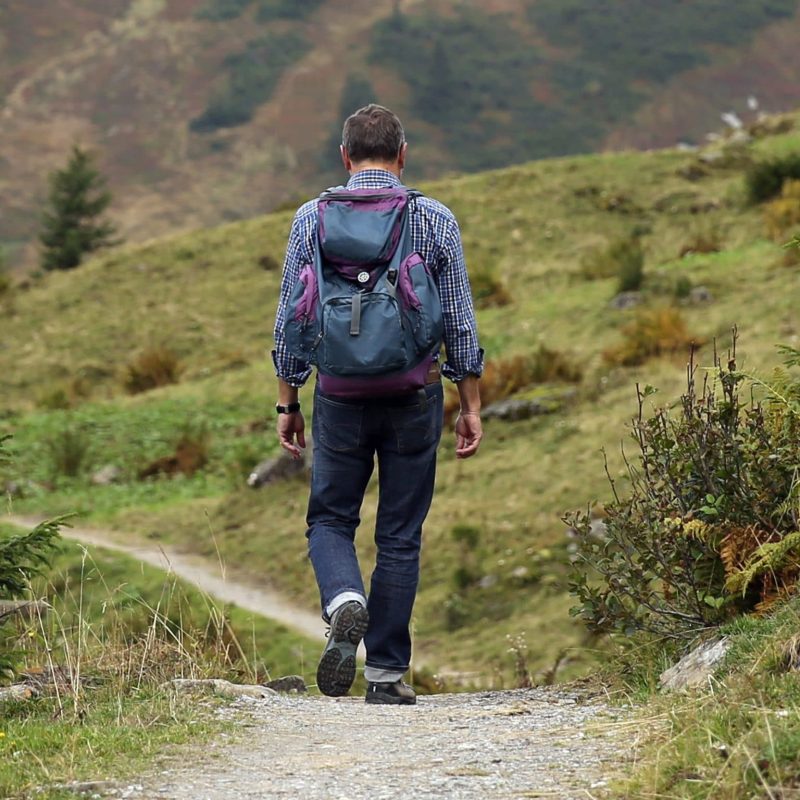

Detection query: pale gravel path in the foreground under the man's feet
xmin=130 ymin=689 xmax=636 ymax=800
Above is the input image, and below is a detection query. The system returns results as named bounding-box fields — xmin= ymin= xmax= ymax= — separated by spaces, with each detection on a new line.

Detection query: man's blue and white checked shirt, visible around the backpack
xmin=272 ymin=169 xmax=483 ymax=387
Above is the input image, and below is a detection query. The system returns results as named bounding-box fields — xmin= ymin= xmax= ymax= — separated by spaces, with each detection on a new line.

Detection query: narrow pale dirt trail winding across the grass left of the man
xmin=0 ymin=515 xmax=325 ymax=639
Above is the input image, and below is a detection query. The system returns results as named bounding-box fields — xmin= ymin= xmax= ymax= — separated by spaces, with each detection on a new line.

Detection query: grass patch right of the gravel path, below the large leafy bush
xmin=618 ymin=600 xmax=800 ymax=800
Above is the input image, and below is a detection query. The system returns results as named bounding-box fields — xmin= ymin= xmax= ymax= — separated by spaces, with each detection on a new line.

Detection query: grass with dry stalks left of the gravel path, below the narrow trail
xmin=0 ymin=527 xmax=317 ymax=798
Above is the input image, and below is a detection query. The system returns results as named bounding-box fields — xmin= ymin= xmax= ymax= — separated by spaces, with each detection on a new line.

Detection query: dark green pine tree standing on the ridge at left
xmin=39 ymin=146 xmax=118 ymax=270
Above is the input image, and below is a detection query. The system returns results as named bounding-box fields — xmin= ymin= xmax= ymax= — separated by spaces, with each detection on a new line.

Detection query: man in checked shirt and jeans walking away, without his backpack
xmin=273 ymin=104 xmax=483 ymax=705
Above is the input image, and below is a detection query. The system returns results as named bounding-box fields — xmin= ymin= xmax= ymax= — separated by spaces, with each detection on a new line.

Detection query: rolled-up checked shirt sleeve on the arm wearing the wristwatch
xmin=272 ymin=204 xmax=316 ymax=387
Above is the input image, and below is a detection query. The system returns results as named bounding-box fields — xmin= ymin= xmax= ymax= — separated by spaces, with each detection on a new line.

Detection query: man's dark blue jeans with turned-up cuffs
xmin=306 ymin=383 xmax=443 ymax=672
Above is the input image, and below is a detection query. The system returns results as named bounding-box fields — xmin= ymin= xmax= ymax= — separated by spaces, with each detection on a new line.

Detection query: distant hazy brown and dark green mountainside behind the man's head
xmin=0 ymin=0 xmax=800 ymax=265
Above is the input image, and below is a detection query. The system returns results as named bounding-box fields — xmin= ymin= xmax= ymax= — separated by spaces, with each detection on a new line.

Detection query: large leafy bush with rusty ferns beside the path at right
xmin=567 ymin=340 xmax=800 ymax=638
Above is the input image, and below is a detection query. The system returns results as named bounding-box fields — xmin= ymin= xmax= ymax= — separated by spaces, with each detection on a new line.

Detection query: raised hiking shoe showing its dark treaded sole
xmin=317 ymin=600 xmax=369 ymax=697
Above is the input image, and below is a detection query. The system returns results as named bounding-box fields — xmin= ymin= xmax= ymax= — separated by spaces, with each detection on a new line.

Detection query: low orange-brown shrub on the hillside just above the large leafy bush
xmin=603 ymin=306 xmax=702 ymax=367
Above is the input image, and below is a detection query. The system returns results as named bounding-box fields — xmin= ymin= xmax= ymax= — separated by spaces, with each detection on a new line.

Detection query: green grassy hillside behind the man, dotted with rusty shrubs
xmin=0 ymin=121 xmax=800 ymax=684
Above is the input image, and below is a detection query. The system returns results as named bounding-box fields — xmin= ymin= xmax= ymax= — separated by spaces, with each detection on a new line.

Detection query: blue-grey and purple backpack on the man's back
xmin=284 ymin=187 xmax=444 ymax=397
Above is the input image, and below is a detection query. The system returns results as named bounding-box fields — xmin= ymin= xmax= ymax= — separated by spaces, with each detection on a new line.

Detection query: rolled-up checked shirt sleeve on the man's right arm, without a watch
xmin=438 ymin=217 xmax=483 ymax=383
